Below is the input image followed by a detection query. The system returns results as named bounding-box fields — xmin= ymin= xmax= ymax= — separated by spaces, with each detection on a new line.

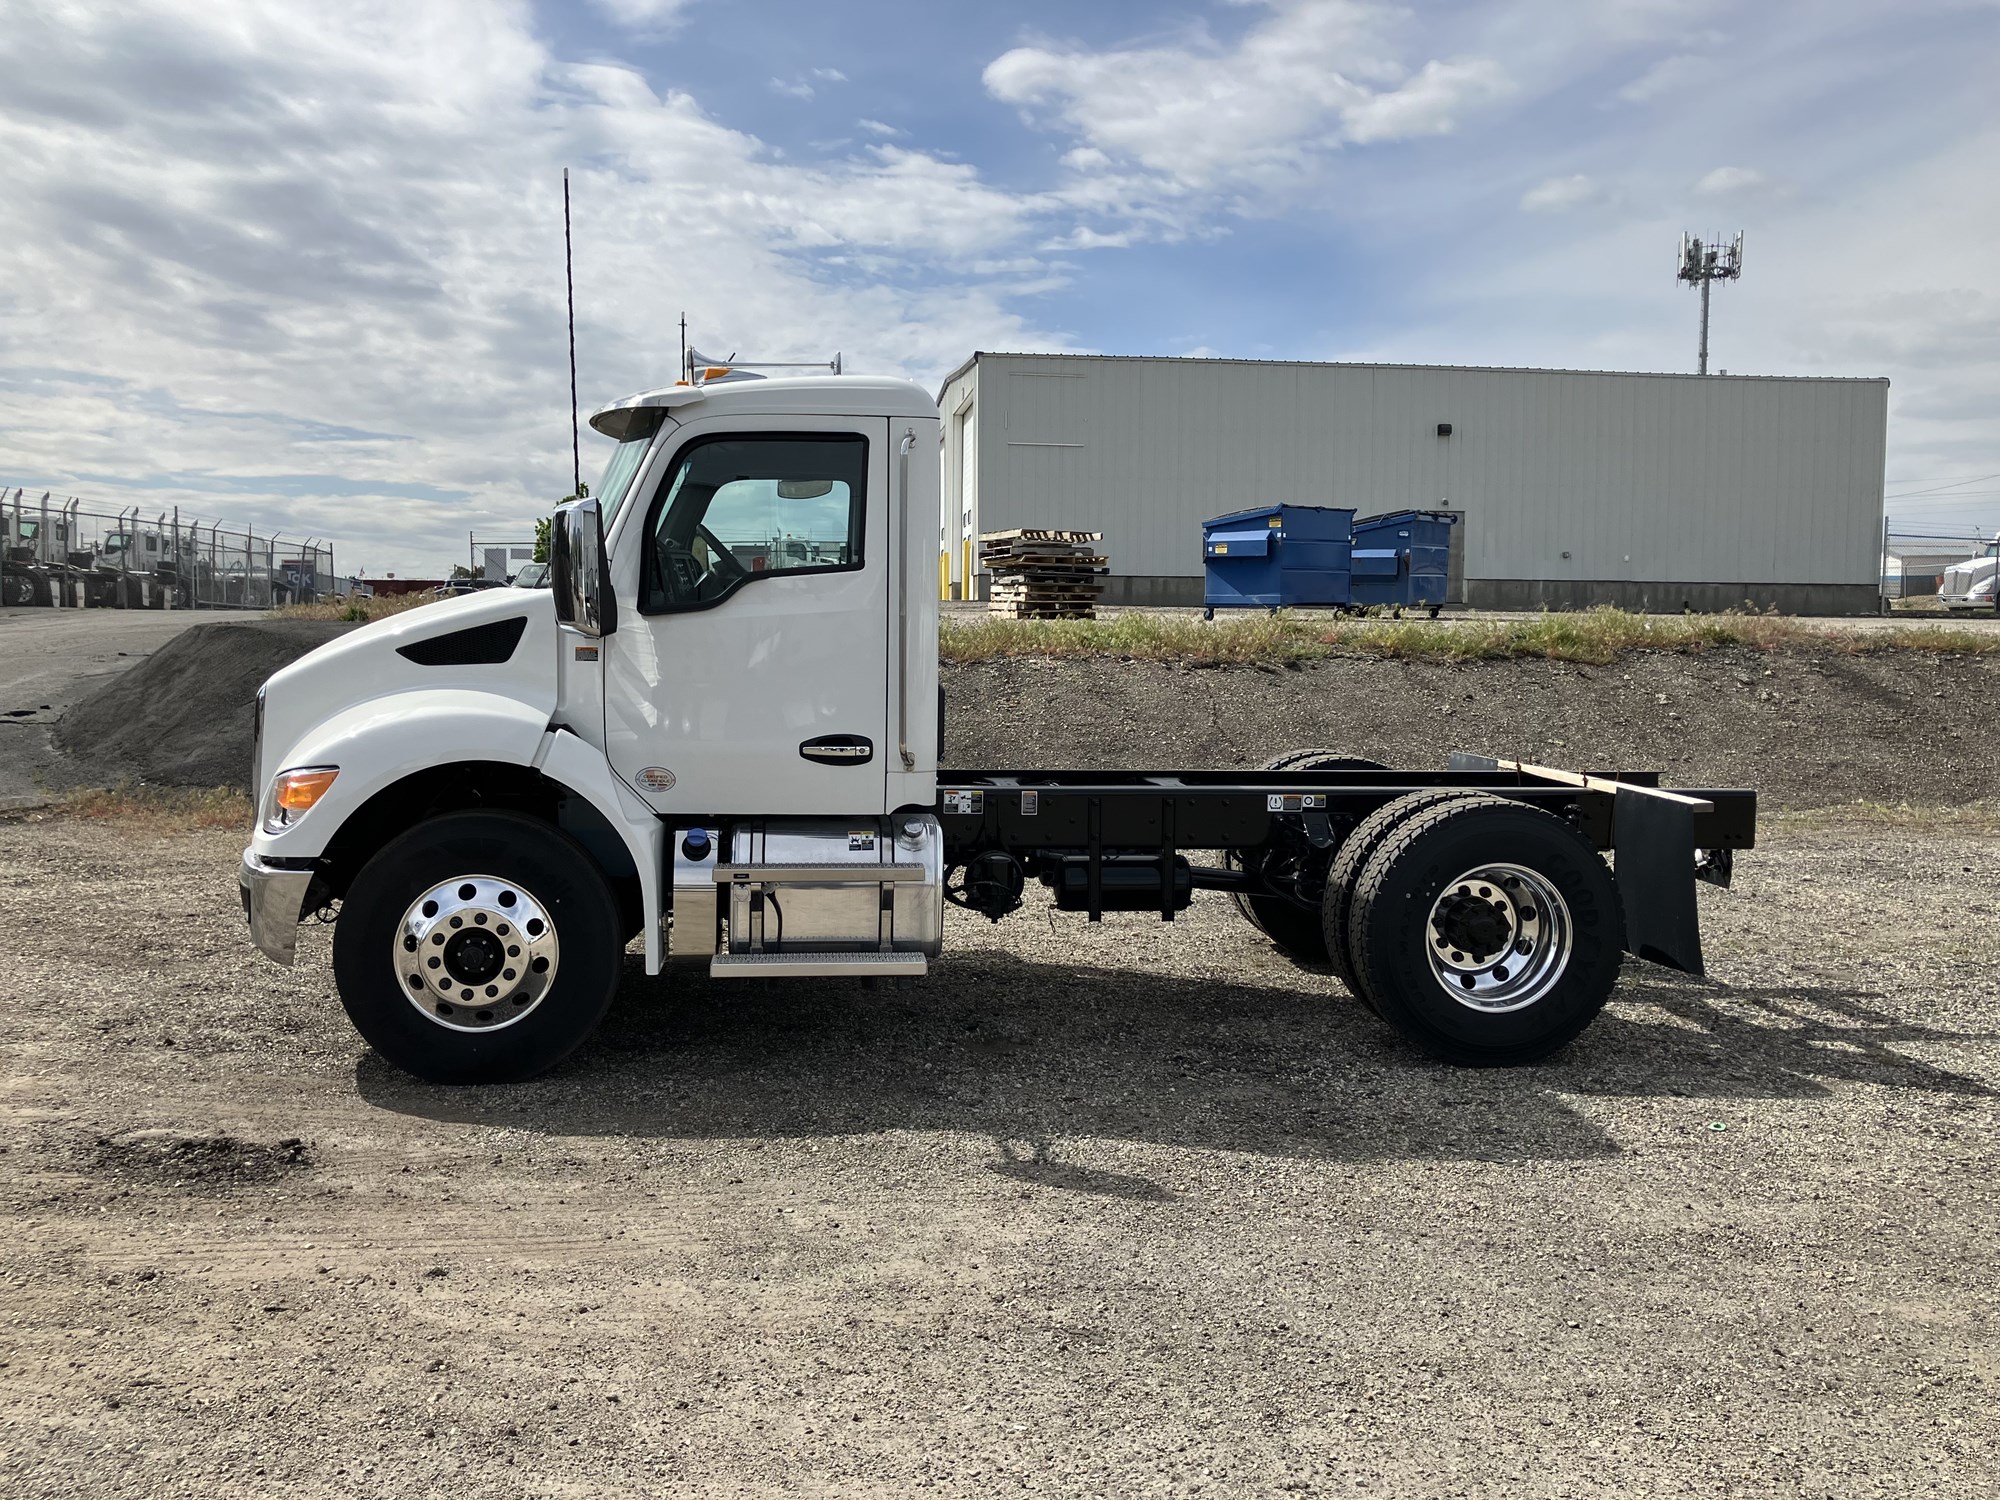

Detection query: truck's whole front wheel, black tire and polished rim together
xmin=334 ymin=812 xmax=624 ymax=1084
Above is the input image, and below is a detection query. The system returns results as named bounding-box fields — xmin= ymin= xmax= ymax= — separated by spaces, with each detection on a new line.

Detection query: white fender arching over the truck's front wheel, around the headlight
xmin=250 ymin=688 xmax=548 ymax=860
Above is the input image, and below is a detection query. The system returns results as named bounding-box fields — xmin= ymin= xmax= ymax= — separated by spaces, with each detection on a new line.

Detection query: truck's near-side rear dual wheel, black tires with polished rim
xmin=1350 ymin=796 xmax=1624 ymax=1068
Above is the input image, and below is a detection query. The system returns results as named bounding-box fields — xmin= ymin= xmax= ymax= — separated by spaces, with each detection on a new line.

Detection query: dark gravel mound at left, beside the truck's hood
xmin=56 ymin=620 xmax=354 ymax=792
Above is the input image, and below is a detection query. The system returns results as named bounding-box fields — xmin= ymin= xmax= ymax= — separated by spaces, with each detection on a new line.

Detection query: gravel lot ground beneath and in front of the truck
xmin=0 ymin=816 xmax=2000 ymax=1500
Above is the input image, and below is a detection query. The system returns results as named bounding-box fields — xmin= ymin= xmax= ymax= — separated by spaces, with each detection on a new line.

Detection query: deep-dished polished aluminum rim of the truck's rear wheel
xmin=1424 ymin=864 xmax=1572 ymax=1014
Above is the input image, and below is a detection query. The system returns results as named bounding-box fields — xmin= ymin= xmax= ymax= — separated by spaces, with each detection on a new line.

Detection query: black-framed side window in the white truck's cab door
xmin=640 ymin=432 xmax=868 ymax=614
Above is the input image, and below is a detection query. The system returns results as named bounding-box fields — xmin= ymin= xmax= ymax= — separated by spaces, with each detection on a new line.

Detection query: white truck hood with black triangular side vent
xmin=254 ymin=588 xmax=556 ymax=790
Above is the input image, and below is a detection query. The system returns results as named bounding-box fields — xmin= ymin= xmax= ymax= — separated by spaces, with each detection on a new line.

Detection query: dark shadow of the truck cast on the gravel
xmin=356 ymin=952 xmax=1988 ymax=1198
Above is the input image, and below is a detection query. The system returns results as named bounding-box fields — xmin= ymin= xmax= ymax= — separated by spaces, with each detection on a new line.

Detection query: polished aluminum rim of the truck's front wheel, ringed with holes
xmin=394 ymin=876 xmax=562 ymax=1032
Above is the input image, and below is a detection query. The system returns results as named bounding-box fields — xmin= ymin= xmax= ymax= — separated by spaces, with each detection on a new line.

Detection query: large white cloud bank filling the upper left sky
xmin=0 ymin=0 xmax=1068 ymax=574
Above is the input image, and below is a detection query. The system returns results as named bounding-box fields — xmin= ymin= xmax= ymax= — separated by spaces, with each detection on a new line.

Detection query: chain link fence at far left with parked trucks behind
xmin=0 ymin=488 xmax=346 ymax=610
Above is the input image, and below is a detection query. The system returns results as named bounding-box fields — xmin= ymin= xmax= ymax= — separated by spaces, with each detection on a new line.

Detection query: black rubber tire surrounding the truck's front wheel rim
xmin=334 ymin=812 xmax=624 ymax=1084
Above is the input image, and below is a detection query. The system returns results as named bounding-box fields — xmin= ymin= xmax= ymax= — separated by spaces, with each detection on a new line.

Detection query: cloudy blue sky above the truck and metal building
xmin=0 ymin=0 xmax=2000 ymax=574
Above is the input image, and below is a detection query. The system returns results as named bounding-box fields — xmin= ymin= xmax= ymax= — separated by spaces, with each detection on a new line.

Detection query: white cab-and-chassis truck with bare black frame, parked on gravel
xmin=240 ymin=376 xmax=1756 ymax=1082
